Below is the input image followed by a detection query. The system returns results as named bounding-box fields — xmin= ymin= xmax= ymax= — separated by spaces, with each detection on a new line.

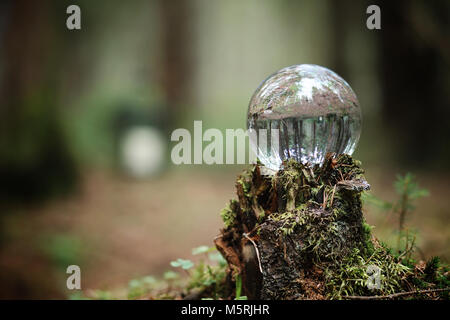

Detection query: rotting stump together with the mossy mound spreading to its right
xmin=215 ymin=154 xmax=450 ymax=300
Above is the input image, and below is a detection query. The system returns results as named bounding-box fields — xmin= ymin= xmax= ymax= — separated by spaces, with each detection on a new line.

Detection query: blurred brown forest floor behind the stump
xmin=0 ymin=168 xmax=450 ymax=299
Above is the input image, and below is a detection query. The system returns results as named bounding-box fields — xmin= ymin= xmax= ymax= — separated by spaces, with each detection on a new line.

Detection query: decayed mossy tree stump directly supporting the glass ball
xmin=215 ymin=154 xmax=372 ymax=299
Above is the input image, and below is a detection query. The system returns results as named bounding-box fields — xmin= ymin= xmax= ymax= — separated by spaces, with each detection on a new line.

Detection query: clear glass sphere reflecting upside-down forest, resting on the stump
xmin=247 ymin=64 xmax=362 ymax=170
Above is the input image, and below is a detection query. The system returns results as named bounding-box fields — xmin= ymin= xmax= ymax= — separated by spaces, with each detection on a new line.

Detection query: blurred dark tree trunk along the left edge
xmin=0 ymin=0 xmax=76 ymax=201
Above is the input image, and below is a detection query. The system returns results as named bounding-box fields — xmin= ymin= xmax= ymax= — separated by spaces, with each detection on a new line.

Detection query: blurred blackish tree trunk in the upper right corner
xmin=380 ymin=1 xmax=450 ymax=167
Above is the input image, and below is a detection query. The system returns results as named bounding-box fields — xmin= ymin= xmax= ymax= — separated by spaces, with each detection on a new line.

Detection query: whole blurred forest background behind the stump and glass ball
xmin=0 ymin=0 xmax=450 ymax=298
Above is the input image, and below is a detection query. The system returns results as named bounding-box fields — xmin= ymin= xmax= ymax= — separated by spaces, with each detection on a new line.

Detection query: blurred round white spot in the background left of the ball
xmin=120 ymin=126 xmax=167 ymax=178
